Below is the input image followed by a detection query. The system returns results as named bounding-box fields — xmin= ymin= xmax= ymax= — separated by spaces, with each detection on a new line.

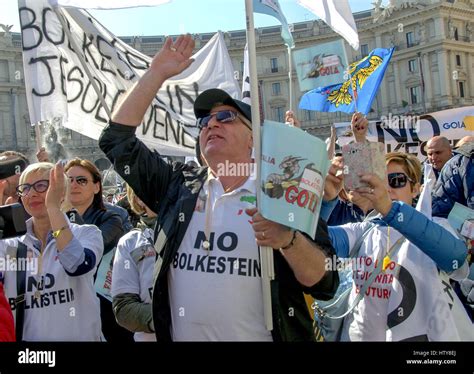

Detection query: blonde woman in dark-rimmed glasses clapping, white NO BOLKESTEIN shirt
xmin=0 ymin=162 xmax=103 ymax=341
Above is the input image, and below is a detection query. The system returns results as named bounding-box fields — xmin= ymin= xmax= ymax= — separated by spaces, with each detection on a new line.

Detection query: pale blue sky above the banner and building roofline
xmin=0 ymin=0 xmax=374 ymax=36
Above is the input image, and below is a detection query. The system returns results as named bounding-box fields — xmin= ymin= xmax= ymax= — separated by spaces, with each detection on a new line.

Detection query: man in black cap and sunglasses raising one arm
xmin=99 ymin=35 xmax=338 ymax=341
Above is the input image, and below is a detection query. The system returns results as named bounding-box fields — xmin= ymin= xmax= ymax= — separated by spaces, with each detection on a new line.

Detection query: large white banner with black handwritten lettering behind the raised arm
xmin=19 ymin=0 xmax=240 ymax=156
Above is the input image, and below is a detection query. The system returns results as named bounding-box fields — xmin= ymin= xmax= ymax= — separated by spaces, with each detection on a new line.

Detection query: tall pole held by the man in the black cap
xmin=245 ymin=0 xmax=274 ymax=331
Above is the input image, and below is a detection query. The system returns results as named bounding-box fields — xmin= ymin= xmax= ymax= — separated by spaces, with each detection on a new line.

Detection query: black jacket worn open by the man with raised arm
xmin=99 ymin=123 xmax=339 ymax=341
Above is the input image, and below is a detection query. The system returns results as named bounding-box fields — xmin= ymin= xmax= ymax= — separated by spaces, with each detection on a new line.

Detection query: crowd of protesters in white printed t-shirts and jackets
xmin=0 ymin=36 xmax=474 ymax=342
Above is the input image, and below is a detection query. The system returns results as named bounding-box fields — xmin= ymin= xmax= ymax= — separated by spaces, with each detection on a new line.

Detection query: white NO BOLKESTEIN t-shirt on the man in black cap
xmin=168 ymin=177 xmax=272 ymax=341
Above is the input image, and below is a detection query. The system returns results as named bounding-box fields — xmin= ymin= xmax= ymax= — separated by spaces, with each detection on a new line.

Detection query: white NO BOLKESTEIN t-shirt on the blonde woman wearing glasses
xmin=0 ymin=218 xmax=104 ymax=341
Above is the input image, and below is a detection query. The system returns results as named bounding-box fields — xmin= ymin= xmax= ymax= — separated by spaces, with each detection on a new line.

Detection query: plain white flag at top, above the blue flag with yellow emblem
xmin=297 ymin=0 xmax=359 ymax=50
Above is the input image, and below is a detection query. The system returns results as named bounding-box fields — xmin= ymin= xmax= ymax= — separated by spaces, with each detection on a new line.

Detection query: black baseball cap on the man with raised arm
xmin=194 ymin=88 xmax=252 ymax=122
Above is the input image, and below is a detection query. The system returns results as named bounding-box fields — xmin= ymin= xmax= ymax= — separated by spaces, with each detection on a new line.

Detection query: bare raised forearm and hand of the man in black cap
xmin=111 ymin=34 xmax=194 ymax=127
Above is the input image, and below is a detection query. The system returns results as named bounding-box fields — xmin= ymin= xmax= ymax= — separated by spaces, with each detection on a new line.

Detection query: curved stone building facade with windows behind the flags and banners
xmin=0 ymin=0 xmax=474 ymax=160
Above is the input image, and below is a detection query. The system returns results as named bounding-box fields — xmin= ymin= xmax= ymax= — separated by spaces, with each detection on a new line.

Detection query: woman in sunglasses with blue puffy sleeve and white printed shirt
xmin=326 ymin=152 xmax=468 ymax=341
